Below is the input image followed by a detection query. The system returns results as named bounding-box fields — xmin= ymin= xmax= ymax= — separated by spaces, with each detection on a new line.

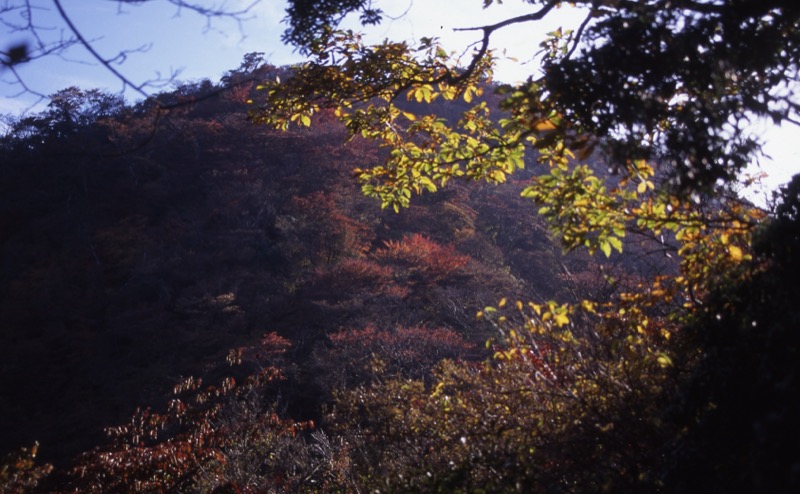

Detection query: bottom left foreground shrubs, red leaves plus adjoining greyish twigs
xmin=28 ymin=333 xmax=340 ymax=492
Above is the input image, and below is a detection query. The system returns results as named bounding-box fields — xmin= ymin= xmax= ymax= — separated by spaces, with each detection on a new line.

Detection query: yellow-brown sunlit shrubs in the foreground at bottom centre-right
xmin=334 ymin=282 xmax=684 ymax=492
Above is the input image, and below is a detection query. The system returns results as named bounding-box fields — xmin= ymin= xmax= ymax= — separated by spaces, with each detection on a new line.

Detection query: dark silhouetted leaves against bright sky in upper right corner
xmin=528 ymin=1 xmax=800 ymax=190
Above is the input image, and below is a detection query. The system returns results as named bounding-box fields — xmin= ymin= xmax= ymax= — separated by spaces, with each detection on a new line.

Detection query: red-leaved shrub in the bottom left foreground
xmin=45 ymin=333 xmax=313 ymax=493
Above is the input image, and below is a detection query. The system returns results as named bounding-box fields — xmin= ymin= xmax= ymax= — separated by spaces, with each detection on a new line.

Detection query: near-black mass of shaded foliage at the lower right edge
xmin=665 ymin=176 xmax=800 ymax=492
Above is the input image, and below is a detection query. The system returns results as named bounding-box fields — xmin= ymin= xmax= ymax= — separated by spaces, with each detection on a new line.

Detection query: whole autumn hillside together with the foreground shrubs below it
xmin=0 ymin=52 xmax=797 ymax=492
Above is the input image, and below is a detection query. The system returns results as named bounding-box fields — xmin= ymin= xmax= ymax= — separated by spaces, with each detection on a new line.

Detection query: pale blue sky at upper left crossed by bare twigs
xmin=0 ymin=0 xmax=297 ymax=113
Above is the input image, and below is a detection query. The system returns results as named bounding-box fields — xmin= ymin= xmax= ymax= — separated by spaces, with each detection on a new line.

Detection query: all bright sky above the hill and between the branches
xmin=0 ymin=0 xmax=800 ymax=204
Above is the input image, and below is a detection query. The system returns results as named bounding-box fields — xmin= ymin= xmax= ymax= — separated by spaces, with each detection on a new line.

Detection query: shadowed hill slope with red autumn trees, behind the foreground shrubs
xmin=0 ymin=59 xmax=637 ymax=476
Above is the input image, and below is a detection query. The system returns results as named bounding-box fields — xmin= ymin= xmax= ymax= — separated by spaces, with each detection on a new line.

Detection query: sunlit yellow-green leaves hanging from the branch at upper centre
xmin=250 ymin=32 xmax=536 ymax=211
